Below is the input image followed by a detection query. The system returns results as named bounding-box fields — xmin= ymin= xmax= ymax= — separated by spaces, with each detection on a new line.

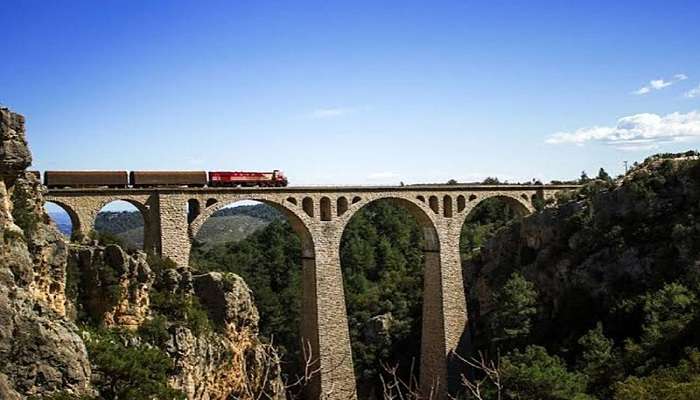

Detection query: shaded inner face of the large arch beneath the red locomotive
xmin=188 ymin=196 xmax=322 ymax=392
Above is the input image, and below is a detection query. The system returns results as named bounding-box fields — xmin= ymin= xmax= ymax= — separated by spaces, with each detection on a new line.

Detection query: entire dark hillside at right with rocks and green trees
xmin=465 ymin=153 xmax=700 ymax=400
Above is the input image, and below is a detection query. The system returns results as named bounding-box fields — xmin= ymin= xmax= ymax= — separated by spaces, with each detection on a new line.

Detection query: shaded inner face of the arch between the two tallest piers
xmin=340 ymin=196 xmax=446 ymax=393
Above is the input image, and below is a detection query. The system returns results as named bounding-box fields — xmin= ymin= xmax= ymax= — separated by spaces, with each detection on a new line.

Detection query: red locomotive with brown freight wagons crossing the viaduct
xmin=41 ymin=170 xmax=288 ymax=189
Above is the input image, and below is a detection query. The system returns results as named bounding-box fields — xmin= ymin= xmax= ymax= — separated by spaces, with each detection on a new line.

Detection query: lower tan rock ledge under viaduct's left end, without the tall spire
xmin=69 ymin=236 xmax=284 ymax=400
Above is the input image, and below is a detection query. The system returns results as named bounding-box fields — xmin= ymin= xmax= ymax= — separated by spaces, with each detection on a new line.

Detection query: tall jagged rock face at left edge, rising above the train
xmin=0 ymin=109 xmax=93 ymax=399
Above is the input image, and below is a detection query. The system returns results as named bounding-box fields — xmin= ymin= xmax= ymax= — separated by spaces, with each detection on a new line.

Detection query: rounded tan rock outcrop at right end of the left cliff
xmin=166 ymin=270 xmax=285 ymax=400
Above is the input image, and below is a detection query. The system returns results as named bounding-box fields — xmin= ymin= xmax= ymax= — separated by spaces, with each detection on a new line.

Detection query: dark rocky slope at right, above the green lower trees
xmin=464 ymin=155 xmax=700 ymax=354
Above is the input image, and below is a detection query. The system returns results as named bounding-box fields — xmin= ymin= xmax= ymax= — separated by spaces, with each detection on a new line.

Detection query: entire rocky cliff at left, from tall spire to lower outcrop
xmin=0 ymin=108 xmax=284 ymax=400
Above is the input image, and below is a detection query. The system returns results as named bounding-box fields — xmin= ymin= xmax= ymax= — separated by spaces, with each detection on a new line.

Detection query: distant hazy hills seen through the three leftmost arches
xmin=49 ymin=204 xmax=284 ymax=249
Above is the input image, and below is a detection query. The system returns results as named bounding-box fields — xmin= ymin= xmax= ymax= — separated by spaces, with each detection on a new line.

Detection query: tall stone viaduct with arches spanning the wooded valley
xmin=46 ymin=185 xmax=577 ymax=399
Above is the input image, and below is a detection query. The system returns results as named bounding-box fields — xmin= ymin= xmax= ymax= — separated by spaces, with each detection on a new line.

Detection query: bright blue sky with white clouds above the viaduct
xmin=0 ymin=0 xmax=700 ymax=185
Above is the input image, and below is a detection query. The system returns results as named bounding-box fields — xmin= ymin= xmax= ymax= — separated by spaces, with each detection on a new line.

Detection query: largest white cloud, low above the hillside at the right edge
xmin=546 ymin=111 xmax=700 ymax=150
